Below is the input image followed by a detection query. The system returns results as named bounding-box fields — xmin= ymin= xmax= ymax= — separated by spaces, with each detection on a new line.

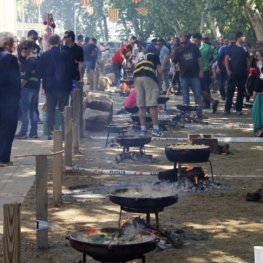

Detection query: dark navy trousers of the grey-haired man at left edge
xmin=0 ymin=94 xmax=19 ymax=163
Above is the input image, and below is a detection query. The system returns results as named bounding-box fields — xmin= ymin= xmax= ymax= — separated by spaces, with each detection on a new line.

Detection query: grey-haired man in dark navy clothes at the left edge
xmin=0 ymin=32 xmax=21 ymax=167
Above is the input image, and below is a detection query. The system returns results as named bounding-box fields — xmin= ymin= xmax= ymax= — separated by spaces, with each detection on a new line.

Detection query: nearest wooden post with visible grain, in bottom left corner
xmin=3 ymin=203 xmax=21 ymax=263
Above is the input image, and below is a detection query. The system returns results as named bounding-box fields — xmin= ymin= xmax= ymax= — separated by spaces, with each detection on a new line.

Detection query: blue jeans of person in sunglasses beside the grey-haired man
xmin=20 ymin=87 xmax=39 ymax=135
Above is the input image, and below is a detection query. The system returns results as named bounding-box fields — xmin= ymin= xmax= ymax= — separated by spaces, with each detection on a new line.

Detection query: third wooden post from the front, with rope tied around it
xmin=53 ymin=131 xmax=62 ymax=205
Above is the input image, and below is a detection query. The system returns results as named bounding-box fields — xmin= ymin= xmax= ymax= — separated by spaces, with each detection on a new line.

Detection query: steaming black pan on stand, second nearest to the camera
xmin=109 ymin=188 xmax=178 ymax=209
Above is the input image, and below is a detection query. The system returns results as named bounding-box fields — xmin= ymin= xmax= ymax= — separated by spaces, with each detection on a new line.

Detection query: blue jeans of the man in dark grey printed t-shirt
xmin=180 ymin=77 xmax=203 ymax=116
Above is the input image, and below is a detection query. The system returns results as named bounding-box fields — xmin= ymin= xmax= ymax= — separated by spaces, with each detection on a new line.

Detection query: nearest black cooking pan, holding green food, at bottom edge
xmin=67 ymin=228 xmax=157 ymax=262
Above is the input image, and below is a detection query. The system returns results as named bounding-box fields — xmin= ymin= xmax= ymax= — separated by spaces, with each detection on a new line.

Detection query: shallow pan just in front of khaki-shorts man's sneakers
xmin=116 ymin=135 xmax=152 ymax=147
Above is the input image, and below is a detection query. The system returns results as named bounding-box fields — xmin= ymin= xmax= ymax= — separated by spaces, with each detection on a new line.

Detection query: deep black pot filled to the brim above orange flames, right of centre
xmin=165 ymin=144 xmax=210 ymax=163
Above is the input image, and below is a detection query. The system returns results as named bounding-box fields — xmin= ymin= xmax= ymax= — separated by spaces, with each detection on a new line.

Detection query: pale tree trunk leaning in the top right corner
xmin=245 ymin=0 xmax=263 ymax=41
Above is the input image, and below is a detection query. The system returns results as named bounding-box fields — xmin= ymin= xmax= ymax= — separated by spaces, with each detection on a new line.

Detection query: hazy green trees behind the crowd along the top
xmin=17 ymin=0 xmax=263 ymax=43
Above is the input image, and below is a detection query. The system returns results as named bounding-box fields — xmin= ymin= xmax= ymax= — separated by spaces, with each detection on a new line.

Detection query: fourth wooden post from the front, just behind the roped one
xmin=65 ymin=107 xmax=72 ymax=166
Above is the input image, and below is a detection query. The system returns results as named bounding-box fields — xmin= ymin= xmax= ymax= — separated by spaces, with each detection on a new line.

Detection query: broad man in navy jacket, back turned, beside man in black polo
xmin=37 ymin=35 xmax=75 ymax=140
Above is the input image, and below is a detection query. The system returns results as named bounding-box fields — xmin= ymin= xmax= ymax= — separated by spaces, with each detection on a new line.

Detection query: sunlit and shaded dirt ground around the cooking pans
xmin=0 ymin=95 xmax=263 ymax=263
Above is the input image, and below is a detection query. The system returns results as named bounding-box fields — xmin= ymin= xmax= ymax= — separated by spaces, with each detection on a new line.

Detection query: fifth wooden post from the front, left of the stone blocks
xmin=73 ymin=89 xmax=80 ymax=153
